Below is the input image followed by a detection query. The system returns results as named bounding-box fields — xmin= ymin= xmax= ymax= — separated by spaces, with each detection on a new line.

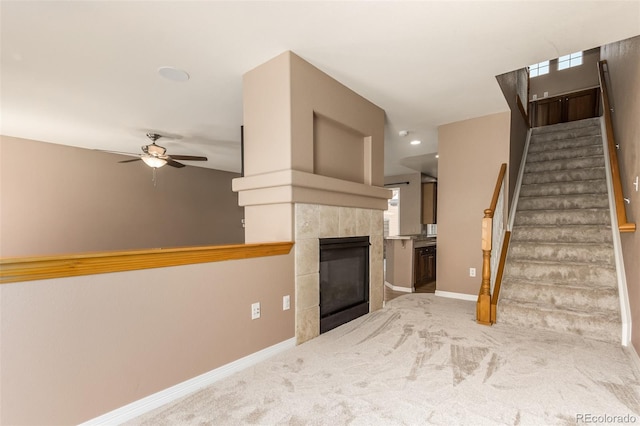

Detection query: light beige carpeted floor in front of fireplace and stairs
xmin=129 ymin=293 xmax=640 ymax=425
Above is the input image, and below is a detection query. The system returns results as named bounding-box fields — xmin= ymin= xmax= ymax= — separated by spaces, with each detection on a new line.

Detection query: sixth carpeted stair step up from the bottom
xmin=514 ymin=209 xmax=611 ymax=226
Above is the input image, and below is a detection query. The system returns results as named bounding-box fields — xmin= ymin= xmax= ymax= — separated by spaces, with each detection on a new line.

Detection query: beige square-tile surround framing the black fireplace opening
xmin=294 ymin=203 xmax=384 ymax=344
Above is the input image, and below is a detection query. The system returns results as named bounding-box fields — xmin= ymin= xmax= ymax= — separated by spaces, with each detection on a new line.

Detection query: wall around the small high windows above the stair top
xmin=529 ymin=48 xmax=600 ymax=100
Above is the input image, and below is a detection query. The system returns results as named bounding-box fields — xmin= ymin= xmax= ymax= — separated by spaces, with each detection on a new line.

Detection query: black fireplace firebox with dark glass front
xmin=320 ymin=237 xmax=370 ymax=333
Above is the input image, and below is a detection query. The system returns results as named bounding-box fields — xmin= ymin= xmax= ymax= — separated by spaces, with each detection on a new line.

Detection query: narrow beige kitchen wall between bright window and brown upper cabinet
xmin=384 ymin=172 xmax=422 ymax=235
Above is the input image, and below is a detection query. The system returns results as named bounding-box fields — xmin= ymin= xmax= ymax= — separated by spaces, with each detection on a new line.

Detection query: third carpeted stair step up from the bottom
xmin=504 ymin=259 xmax=617 ymax=287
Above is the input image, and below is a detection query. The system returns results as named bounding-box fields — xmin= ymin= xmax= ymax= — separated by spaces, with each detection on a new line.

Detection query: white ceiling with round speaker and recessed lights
xmin=0 ymin=0 xmax=640 ymax=175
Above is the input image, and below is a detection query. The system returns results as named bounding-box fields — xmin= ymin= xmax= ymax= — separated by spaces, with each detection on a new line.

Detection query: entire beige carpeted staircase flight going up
xmin=497 ymin=118 xmax=621 ymax=342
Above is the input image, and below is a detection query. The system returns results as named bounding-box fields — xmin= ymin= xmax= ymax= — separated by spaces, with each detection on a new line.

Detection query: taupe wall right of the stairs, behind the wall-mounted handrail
xmin=602 ymin=36 xmax=640 ymax=353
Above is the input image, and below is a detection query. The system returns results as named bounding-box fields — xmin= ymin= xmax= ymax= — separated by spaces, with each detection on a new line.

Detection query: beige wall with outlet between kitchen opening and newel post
xmin=436 ymin=112 xmax=510 ymax=295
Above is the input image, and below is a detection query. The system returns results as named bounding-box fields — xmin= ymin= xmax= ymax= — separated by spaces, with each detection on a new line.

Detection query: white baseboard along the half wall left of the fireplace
xmin=80 ymin=337 xmax=296 ymax=426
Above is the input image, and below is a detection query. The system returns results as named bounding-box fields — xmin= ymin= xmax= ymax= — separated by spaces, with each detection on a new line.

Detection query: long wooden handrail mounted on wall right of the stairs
xmin=598 ymin=60 xmax=636 ymax=232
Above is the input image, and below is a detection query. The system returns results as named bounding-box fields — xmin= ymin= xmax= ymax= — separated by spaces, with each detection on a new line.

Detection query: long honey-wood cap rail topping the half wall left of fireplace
xmin=0 ymin=242 xmax=293 ymax=284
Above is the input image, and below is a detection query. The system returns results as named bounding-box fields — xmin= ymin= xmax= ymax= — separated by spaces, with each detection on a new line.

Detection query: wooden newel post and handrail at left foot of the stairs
xmin=476 ymin=163 xmax=509 ymax=325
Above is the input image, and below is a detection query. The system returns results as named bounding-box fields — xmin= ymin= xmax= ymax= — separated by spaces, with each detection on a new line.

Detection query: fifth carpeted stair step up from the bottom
xmin=510 ymin=225 xmax=613 ymax=244
